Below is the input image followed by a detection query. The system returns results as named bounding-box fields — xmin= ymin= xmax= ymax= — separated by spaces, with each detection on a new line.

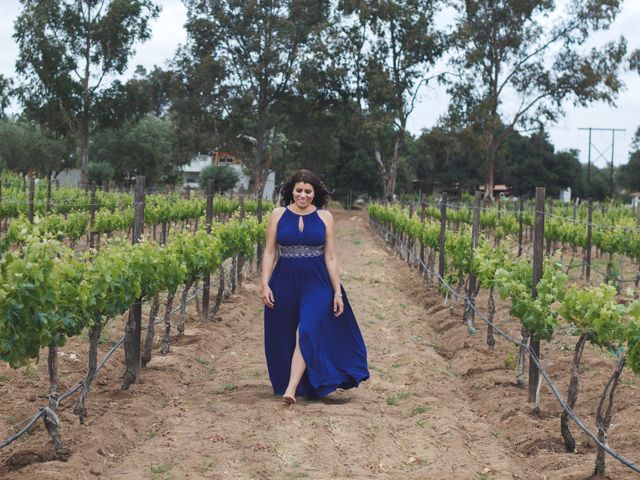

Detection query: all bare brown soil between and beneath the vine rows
xmin=0 ymin=211 xmax=640 ymax=480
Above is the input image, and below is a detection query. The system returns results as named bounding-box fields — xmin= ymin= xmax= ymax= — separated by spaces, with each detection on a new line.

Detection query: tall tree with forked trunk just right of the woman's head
xmin=334 ymin=0 xmax=447 ymax=199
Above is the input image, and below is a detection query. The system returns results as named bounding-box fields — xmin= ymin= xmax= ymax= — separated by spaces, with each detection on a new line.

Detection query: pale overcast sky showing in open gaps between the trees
xmin=0 ymin=0 xmax=640 ymax=166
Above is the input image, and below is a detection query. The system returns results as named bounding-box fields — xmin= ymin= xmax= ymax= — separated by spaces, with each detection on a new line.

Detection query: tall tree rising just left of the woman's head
xmin=184 ymin=0 xmax=330 ymax=214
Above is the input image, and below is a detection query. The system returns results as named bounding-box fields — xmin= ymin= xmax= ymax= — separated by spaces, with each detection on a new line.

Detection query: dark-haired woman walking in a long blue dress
xmin=262 ymin=170 xmax=369 ymax=405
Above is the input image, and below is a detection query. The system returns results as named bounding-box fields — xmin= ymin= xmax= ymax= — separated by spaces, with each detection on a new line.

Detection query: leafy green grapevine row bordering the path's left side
xmin=0 ymin=177 xmax=265 ymax=452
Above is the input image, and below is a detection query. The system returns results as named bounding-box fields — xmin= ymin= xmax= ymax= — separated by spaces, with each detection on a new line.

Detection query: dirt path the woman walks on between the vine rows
xmin=104 ymin=211 xmax=526 ymax=479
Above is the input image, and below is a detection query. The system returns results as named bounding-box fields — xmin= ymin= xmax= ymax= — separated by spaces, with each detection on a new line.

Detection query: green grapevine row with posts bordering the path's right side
xmin=369 ymin=192 xmax=640 ymax=475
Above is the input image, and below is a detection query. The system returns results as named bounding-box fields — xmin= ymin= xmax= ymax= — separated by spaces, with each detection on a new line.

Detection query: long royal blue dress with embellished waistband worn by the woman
xmin=264 ymin=208 xmax=369 ymax=398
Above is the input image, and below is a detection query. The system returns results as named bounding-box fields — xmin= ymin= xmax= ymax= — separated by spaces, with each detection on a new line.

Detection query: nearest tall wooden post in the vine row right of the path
xmin=529 ymin=187 xmax=545 ymax=405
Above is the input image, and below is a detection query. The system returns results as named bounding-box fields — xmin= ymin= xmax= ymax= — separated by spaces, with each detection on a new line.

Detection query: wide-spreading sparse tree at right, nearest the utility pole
xmin=449 ymin=0 xmax=627 ymax=197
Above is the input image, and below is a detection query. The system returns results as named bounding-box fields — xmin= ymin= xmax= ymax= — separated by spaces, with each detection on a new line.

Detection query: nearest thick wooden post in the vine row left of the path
xmin=122 ymin=175 xmax=145 ymax=390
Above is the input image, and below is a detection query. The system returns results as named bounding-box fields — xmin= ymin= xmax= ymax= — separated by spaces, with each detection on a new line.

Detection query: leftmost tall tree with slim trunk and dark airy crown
xmin=14 ymin=0 xmax=160 ymax=185
